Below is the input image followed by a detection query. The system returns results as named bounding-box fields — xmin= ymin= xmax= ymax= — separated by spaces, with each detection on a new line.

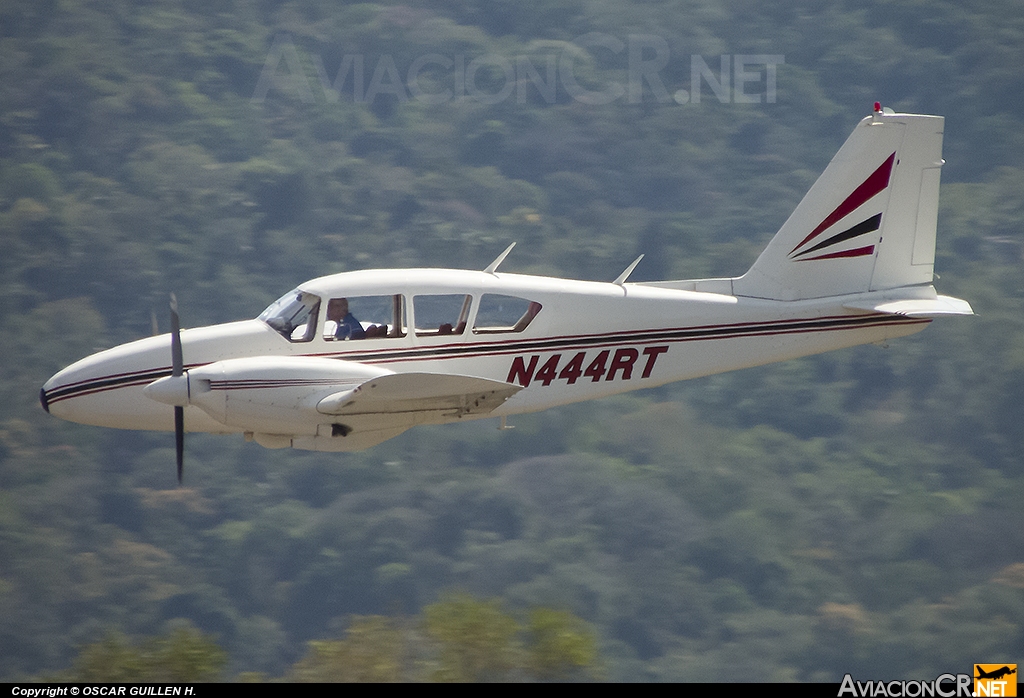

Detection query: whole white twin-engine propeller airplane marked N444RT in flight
xmin=41 ymin=104 xmax=973 ymax=480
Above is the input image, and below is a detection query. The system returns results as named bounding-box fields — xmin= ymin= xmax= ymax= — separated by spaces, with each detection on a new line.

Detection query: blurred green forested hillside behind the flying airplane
xmin=0 ymin=0 xmax=1024 ymax=681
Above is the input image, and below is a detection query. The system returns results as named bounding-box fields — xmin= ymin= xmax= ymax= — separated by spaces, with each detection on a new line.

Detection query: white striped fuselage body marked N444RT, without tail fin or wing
xmin=43 ymin=269 xmax=934 ymax=446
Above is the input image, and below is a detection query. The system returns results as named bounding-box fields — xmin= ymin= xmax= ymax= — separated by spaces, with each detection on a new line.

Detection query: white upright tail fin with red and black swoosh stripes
xmin=733 ymin=112 xmax=943 ymax=300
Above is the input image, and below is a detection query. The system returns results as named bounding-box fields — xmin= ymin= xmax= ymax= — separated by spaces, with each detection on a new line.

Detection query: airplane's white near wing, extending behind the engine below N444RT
xmin=316 ymin=374 xmax=522 ymax=415
